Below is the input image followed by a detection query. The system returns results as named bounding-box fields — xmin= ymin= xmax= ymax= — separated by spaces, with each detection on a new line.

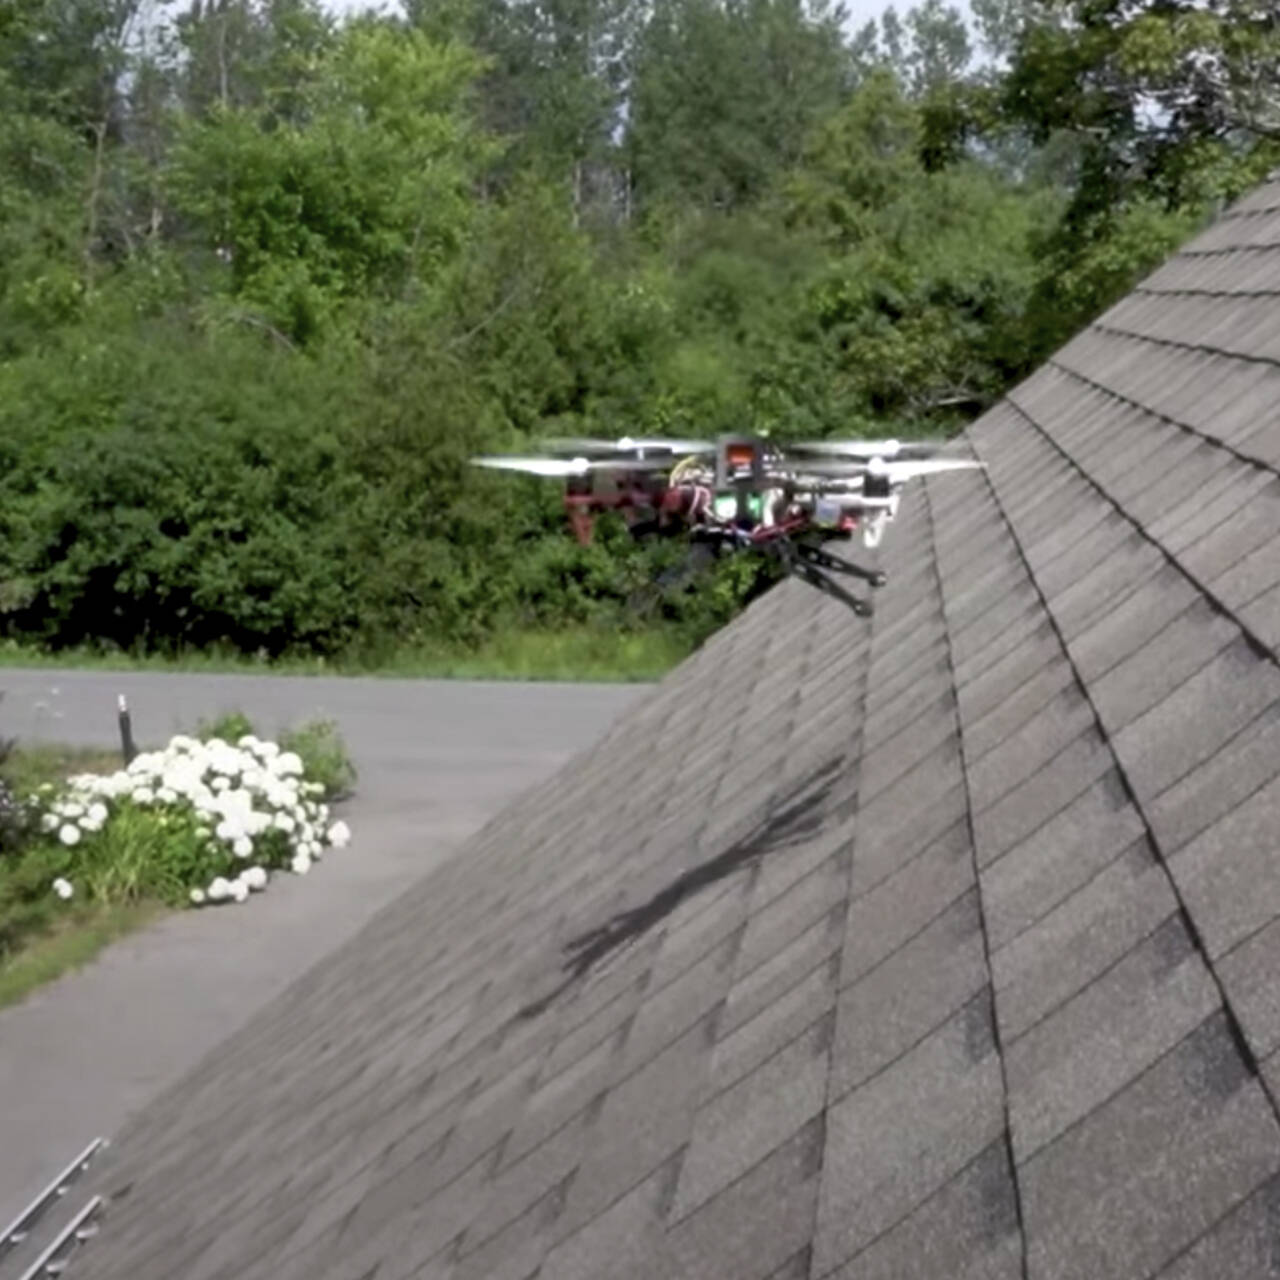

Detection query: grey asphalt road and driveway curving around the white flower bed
xmin=0 ymin=669 xmax=645 ymax=1229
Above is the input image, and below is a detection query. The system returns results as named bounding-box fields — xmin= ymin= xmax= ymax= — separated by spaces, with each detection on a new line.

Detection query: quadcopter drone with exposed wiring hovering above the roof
xmin=471 ymin=435 xmax=983 ymax=617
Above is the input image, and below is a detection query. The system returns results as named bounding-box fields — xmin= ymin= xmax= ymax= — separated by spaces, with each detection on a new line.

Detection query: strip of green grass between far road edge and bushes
xmin=0 ymin=627 xmax=692 ymax=682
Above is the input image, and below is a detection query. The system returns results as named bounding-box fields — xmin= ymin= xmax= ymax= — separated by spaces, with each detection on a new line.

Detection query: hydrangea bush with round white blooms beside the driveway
xmin=27 ymin=733 xmax=351 ymax=905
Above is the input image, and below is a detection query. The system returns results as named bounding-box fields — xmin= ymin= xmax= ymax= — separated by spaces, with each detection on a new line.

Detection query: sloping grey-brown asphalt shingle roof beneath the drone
xmin=72 ymin=175 xmax=1280 ymax=1280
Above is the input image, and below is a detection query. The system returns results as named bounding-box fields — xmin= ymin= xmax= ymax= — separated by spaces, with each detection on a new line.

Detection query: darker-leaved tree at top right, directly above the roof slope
xmin=1000 ymin=0 xmax=1280 ymax=351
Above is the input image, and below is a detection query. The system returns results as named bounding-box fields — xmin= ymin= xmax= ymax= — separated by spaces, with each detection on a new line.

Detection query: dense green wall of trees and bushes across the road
xmin=0 ymin=0 xmax=1280 ymax=655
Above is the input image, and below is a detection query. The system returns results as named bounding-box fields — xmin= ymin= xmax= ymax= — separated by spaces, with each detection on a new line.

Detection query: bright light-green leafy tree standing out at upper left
xmin=170 ymin=23 xmax=485 ymax=342
